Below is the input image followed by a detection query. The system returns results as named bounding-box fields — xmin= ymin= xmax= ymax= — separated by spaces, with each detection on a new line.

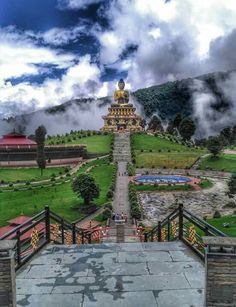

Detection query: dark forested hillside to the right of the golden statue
xmin=133 ymin=72 xmax=232 ymax=120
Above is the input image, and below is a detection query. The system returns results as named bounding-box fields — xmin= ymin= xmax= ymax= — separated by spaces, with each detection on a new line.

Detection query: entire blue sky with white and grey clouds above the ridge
xmin=0 ymin=0 xmax=236 ymax=116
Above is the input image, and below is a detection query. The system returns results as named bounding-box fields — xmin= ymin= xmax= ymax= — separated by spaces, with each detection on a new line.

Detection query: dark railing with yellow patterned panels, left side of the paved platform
xmin=0 ymin=206 xmax=95 ymax=270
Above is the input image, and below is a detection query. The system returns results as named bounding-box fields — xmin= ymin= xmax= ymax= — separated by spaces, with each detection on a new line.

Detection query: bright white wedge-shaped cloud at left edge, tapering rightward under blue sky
xmin=0 ymin=27 xmax=76 ymax=80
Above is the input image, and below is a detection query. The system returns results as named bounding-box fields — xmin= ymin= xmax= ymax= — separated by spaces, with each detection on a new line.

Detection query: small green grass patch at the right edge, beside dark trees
xmin=199 ymin=154 xmax=236 ymax=172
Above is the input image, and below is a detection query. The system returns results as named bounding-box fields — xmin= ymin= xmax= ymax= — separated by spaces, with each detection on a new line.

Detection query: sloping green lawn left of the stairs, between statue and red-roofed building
xmin=47 ymin=134 xmax=112 ymax=154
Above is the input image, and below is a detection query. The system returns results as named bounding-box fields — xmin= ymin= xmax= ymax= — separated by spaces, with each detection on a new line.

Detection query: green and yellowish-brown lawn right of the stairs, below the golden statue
xmin=132 ymin=134 xmax=206 ymax=168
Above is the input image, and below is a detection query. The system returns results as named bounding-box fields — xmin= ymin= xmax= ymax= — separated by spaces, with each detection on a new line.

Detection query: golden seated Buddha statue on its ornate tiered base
xmin=101 ymin=79 xmax=143 ymax=132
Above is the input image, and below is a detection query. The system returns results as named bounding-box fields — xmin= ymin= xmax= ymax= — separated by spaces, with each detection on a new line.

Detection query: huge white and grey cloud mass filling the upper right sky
xmin=96 ymin=0 xmax=236 ymax=89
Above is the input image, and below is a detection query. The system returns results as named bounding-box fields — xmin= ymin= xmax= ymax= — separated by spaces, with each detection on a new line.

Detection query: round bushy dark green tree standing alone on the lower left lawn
xmin=72 ymin=174 xmax=100 ymax=205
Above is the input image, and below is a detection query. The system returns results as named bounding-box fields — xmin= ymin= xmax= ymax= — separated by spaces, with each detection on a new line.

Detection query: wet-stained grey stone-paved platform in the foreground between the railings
xmin=17 ymin=242 xmax=205 ymax=307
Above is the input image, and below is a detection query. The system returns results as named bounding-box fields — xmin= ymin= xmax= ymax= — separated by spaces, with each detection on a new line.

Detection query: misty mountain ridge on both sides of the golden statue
xmin=1 ymin=72 xmax=233 ymax=136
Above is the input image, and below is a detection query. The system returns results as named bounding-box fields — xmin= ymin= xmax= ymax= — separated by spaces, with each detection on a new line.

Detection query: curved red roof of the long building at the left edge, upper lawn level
xmin=0 ymin=132 xmax=37 ymax=146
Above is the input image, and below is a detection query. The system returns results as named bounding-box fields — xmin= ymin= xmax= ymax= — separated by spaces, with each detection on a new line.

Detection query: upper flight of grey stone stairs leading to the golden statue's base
xmin=113 ymin=132 xmax=131 ymax=162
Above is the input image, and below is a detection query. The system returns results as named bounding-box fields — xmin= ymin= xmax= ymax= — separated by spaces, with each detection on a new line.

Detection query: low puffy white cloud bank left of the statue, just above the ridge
xmin=0 ymin=55 xmax=107 ymax=117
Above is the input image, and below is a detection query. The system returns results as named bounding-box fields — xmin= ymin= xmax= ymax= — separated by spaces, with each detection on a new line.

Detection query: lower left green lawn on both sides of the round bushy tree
xmin=0 ymin=159 xmax=113 ymax=226
